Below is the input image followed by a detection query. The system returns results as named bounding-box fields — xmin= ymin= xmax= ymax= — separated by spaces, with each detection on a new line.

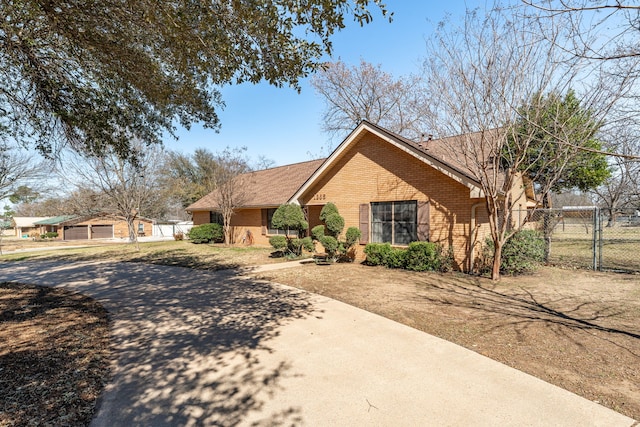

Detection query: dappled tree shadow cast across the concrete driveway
xmin=0 ymin=262 xmax=315 ymax=426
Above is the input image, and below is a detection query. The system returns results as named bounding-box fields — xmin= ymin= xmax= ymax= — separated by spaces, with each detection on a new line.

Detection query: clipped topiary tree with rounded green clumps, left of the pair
xmin=269 ymin=204 xmax=313 ymax=257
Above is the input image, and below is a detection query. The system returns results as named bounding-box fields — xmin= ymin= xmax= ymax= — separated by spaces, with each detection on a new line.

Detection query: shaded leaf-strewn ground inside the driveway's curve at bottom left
xmin=0 ymin=283 xmax=110 ymax=426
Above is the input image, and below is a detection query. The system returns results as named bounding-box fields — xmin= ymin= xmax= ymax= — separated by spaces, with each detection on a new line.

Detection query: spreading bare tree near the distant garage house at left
xmin=64 ymin=141 xmax=161 ymax=249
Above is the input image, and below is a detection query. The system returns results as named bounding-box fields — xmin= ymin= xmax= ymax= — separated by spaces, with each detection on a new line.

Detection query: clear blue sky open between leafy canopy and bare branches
xmin=165 ymin=0 xmax=477 ymax=165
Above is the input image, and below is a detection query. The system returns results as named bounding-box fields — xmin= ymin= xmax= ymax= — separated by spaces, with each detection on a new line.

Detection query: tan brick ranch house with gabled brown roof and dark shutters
xmin=187 ymin=121 xmax=534 ymax=271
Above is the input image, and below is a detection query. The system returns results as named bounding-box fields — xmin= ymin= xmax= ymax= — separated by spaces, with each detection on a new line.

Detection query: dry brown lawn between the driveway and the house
xmin=255 ymin=264 xmax=640 ymax=420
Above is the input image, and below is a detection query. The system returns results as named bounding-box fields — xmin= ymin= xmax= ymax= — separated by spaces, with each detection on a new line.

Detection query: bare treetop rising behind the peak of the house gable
xmin=311 ymin=60 xmax=428 ymax=148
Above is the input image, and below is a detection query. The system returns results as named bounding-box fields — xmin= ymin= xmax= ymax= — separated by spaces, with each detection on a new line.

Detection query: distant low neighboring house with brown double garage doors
xmin=35 ymin=214 xmax=153 ymax=240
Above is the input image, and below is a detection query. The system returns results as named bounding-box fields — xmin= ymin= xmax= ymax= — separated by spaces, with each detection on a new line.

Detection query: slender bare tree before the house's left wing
xmin=214 ymin=147 xmax=253 ymax=245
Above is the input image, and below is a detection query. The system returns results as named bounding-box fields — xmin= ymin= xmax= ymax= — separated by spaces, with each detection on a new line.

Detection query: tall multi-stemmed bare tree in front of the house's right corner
xmin=425 ymin=8 xmax=618 ymax=279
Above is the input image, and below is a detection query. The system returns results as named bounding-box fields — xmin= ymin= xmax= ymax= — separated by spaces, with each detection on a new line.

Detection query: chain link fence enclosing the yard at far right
xmin=514 ymin=206 xmax=640 ymax=272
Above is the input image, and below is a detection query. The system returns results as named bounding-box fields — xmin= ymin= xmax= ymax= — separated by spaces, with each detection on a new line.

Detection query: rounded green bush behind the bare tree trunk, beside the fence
xmin=485 ymin=230 xmax=544 ymax=275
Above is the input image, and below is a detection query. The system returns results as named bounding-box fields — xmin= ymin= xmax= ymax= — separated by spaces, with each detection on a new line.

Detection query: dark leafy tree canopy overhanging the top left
xmin=0 ymin=0 xmax=387 ymax=157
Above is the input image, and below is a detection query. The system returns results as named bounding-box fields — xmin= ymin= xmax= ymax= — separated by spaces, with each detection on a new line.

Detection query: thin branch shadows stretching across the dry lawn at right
xmin=415 ymin=278 xmax=640 ymax=357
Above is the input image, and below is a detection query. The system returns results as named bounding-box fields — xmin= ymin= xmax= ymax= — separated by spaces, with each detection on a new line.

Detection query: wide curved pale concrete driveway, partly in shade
xmin=0 ymin=262 xmax=637 ymax=427
